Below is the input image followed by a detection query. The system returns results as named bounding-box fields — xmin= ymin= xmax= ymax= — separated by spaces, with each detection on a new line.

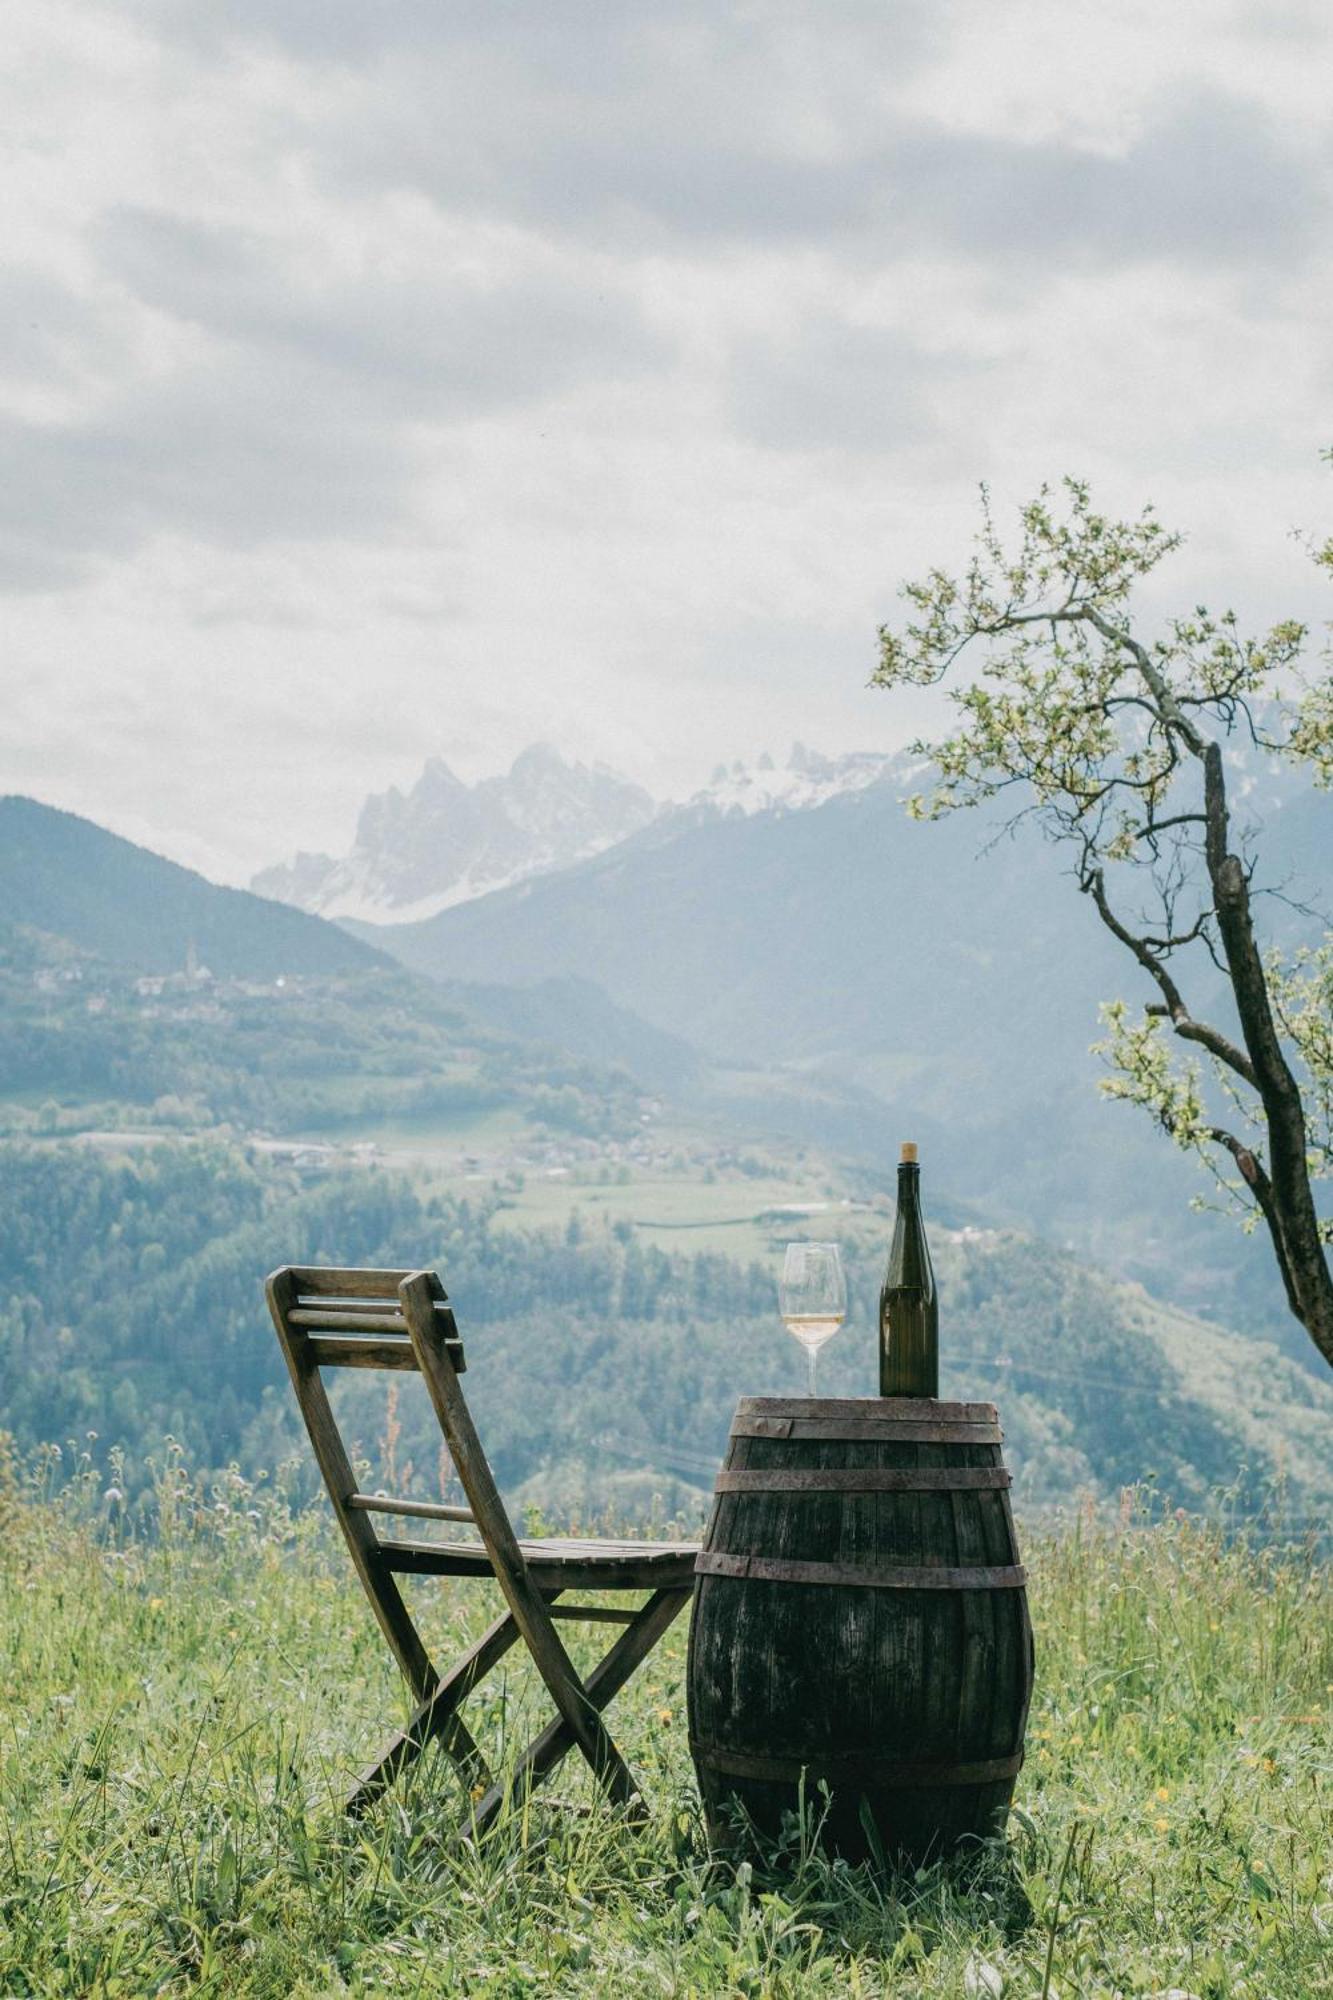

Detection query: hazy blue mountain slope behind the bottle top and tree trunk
xmin=358 ymin=780 xmax=1327 ymax=1352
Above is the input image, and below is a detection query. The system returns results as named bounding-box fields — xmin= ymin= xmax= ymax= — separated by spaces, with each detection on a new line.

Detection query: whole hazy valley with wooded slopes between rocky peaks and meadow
xmin=0 ymin=766 xmax=1333 ymax=1528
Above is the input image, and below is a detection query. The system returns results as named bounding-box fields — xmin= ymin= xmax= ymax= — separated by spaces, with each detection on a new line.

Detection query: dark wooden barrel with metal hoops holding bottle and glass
xmin=689 ymin=1396 xmax=1033 ymax=1860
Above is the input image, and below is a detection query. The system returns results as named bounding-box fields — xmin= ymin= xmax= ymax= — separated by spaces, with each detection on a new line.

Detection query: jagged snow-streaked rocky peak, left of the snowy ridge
xmin=254 ymin=744 xmax=656 ymax=922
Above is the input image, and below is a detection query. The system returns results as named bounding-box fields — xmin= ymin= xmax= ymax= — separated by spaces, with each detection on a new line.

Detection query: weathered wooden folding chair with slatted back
xmin=266 ymin=1266 xmax=699 ymax=1834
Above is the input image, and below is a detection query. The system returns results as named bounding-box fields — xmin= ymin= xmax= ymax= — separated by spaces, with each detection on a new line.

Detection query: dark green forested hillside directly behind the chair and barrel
xmin=0 ymin=1142 xmax=1333 ymax=1514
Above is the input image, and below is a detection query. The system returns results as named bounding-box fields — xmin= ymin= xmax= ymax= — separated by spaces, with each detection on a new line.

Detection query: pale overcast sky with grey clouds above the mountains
xmin=0 ymin=0 xmax=1333 ymax=882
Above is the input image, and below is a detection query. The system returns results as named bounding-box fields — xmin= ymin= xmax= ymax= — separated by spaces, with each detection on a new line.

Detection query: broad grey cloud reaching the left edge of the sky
xmin=0 ymin=208 xmax=667 ymax=590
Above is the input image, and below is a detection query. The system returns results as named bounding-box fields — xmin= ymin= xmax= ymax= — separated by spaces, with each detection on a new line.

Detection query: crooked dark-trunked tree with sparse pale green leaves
xmin=873 ymin=480 xmax=1333 ymax=1366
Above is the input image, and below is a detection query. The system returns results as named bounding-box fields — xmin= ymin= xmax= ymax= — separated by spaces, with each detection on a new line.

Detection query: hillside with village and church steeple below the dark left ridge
xmin=0 ymin=898 xmax=638 ymax=1134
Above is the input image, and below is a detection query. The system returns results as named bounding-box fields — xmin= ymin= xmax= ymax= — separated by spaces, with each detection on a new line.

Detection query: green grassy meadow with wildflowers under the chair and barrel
xmin=0 ymin=1452 xmax=1333 ymax=2000
